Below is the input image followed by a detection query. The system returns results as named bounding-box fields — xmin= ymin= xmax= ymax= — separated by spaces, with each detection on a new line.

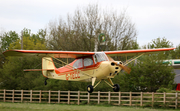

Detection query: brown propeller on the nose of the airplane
xmin=107 ymin=56 xmax=131 ymax=74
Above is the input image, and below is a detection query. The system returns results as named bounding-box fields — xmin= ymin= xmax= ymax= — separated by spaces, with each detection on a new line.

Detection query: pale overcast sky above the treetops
xmin=0 ymin=0 xmax=180 ymax=47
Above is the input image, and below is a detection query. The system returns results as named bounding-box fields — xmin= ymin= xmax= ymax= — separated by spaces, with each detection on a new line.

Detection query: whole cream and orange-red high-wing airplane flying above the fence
xmin=3 ymin=48 xmax=175 ymax=93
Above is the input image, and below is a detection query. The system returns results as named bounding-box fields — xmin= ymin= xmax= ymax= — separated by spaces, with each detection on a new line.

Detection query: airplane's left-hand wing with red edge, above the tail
xmin=3 ymin=50 xmax=94 ymax=58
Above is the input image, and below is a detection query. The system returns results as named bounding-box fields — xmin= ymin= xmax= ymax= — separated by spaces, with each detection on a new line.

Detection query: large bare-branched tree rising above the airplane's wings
xmin=48 ymin=4 xmax=136 ymax=51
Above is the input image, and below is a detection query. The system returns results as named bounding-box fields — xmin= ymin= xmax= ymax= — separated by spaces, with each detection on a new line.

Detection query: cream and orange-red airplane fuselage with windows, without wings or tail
xmin=44 ymin=52 xmax=121 ymax=82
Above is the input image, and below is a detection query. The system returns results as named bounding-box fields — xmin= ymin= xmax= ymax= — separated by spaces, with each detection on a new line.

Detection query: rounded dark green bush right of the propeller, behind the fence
xmin=120 ymin=54 xmax=175 ymax=92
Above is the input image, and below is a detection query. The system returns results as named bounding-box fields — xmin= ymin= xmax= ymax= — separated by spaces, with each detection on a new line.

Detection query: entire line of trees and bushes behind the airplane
xmin=0 ymin=4 xmax=180 ymax=91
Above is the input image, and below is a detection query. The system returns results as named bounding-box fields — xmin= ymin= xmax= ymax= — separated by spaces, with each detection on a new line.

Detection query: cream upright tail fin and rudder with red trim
xmin=42 ymin=57 xmax=56 ymax=78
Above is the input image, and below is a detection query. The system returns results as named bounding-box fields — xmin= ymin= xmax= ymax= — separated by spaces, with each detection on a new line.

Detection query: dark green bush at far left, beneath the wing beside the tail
xmin=0 ymin=57 xmax=41 ymax=89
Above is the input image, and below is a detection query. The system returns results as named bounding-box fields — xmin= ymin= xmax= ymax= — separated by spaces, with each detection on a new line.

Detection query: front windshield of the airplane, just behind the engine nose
xmin=94 ymin=53 xmax=108 ymax=62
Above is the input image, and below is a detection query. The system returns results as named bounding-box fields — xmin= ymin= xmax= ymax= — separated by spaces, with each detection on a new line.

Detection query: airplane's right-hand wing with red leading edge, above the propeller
xmin=105 ymin=48 xmax=175 ymax=56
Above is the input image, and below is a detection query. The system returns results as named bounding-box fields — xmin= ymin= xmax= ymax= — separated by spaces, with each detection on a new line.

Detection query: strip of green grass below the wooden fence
xmin=0 ymin=102 xmax=178 ymax=111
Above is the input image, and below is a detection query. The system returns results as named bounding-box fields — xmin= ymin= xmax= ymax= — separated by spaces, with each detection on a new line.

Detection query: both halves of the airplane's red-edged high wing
xmin=3 ymin=48 xmax=175 ymax=58
